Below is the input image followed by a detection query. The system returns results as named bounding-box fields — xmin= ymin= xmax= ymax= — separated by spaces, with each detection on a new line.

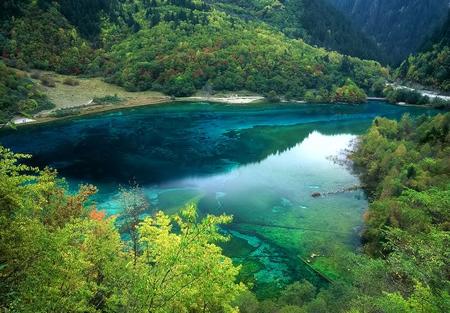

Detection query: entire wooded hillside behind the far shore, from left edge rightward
xmin=0 ymin=0 xmax=387 ymax=101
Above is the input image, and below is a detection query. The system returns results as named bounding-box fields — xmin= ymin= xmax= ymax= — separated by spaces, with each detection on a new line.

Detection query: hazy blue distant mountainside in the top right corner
xmin=328 ymin=0 xmax=449 ymax=64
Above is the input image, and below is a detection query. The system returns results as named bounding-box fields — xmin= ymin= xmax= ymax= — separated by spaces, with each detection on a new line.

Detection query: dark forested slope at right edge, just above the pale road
xmin=396 ymin=13 xmax=450 ymax=92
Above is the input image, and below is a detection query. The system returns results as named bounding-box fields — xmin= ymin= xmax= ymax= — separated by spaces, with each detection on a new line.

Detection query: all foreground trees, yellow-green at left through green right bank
xmin=0 ymin=113 xmax=450 ymax=313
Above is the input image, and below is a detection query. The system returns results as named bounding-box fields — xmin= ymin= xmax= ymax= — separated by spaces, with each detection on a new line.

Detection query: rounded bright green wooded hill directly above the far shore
xmin=103 ymin=11 xmax=387 ymax=97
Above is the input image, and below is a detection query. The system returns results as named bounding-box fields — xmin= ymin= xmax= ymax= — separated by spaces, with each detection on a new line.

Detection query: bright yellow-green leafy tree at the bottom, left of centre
xmin=107 ymin=205 xmax=244 ymax=313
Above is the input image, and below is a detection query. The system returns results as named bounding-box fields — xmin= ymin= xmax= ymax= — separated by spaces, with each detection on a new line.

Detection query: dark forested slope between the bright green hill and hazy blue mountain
xmin=207 ymin=0 xmax=383 ymax=60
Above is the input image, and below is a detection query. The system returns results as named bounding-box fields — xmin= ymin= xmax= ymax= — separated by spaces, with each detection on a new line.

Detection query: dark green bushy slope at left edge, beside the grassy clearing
xmin=0 ymin=62 xmax=53 ymax=124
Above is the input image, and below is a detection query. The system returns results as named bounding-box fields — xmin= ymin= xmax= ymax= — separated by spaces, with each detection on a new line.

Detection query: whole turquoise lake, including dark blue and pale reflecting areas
xmin=0 ymin=102 xmax=436 ymax=296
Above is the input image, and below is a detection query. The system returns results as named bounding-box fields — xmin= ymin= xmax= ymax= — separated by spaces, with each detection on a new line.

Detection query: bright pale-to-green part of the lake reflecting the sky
xmin=100 ymin=131 xmax=367 ymax=290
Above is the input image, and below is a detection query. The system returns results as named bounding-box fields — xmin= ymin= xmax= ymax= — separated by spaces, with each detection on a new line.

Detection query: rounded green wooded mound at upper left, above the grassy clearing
xmin=3 ymin=4 xmax=93 ymax=74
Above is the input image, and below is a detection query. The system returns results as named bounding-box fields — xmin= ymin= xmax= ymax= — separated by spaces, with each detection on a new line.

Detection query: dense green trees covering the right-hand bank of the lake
xmin=238 ymin=113 xmax=450 ymax=313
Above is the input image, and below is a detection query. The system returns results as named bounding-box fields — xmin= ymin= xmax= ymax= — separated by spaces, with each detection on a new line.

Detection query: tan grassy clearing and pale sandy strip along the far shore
xmin=7 ymin=72 xmax=442 ymax=127
